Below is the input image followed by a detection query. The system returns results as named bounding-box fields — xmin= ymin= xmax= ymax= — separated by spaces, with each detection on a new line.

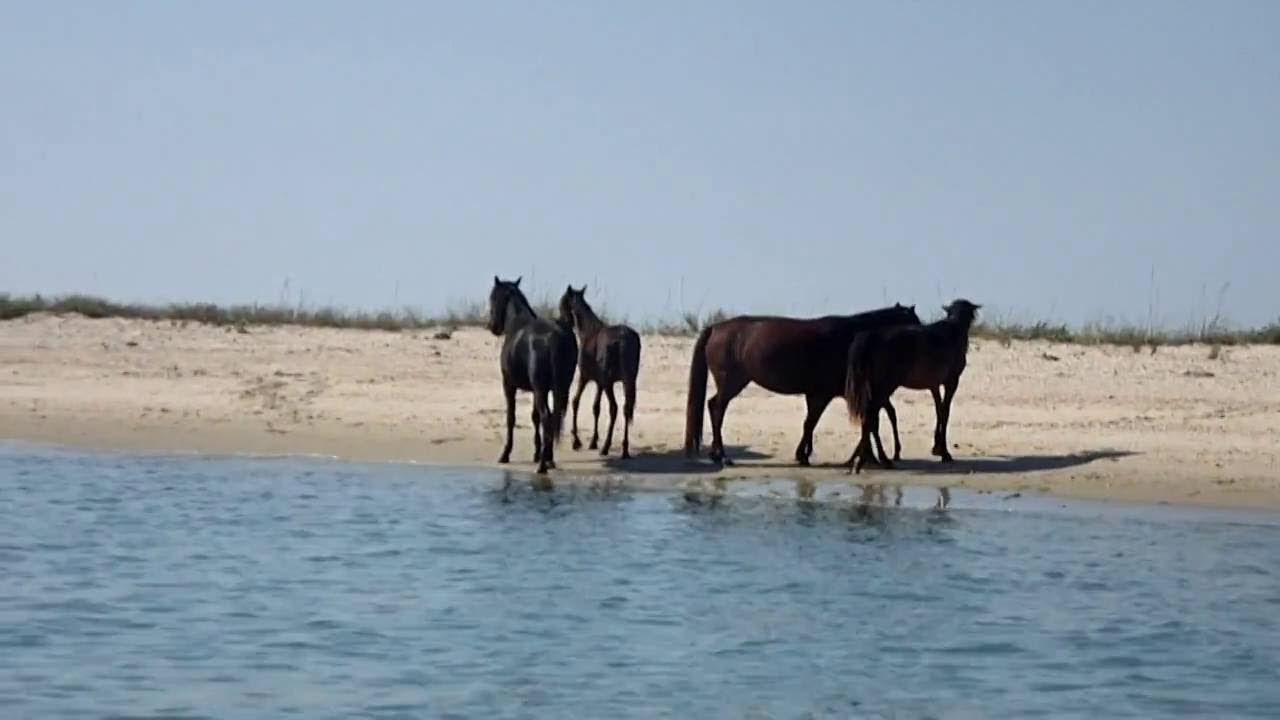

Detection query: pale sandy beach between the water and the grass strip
xmin=0 ymin=315 xmax=1280 ymax=509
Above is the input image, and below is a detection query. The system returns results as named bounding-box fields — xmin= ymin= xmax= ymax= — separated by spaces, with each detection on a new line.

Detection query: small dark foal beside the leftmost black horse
xmin=559 ymin=284 xmax=640 ymax=460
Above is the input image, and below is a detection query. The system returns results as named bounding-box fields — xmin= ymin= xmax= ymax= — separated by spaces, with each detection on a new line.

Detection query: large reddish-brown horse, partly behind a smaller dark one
xmin=685 ymin=304 xmax=920 ymax=465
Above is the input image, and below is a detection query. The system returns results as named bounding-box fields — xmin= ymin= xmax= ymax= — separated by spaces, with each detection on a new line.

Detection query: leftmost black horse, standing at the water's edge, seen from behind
xmin=489 ymin=275 xmax=577 ymax=474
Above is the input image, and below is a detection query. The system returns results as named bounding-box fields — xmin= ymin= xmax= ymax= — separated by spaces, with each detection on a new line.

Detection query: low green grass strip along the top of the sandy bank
xmin=0 ymin=293 xmax=1280 ymax=351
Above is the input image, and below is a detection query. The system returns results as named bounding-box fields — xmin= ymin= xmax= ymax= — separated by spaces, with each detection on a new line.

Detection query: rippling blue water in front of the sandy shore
xmin=0 ymin=446 xmax=1280 ymax=719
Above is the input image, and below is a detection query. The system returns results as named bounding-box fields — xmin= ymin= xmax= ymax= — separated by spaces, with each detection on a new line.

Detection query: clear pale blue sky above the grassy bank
xmin=0 ymin=0 xmax=1280 ymax=327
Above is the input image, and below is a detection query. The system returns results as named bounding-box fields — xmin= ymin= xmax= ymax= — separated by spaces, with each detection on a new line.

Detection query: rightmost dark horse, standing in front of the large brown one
xmin=845 ymin=299 xmax=982 ymax=473
